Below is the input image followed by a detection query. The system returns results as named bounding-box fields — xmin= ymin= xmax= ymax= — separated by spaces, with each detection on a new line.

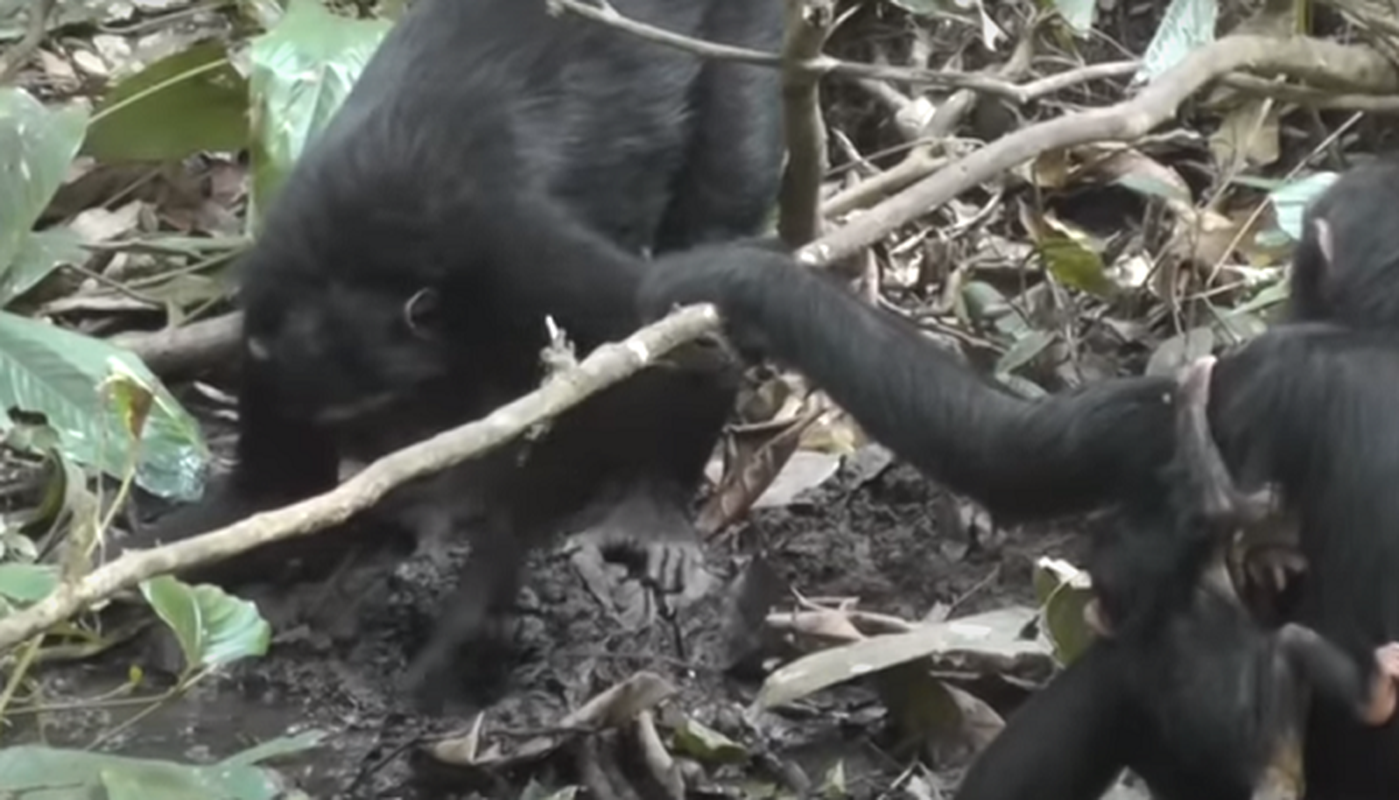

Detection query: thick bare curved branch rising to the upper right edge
xmin=802 ymin=36 xmax=1399 ymax=264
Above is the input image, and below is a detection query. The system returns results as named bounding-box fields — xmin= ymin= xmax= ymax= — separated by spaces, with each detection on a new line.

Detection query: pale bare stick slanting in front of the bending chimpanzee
xmin=0 ymin=305 xmax=719 ymax=649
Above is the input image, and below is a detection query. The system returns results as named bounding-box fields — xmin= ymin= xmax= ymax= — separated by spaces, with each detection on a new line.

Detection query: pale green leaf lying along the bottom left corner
xmin=0 ymin=745 xmax=300 ymax=800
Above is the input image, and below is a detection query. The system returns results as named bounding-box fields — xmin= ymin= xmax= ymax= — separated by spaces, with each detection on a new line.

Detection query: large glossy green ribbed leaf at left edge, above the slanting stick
xmin=0 ymin=312 xmax=208 ymax=499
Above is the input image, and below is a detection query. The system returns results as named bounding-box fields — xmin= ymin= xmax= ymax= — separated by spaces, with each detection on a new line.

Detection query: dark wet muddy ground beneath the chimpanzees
xmin=11 ymin=405 xmax=1079 ymax=800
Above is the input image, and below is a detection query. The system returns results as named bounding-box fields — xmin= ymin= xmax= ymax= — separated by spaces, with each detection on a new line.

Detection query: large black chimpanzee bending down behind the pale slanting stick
xmin=139 ymin=0 xmax=782 ymax=713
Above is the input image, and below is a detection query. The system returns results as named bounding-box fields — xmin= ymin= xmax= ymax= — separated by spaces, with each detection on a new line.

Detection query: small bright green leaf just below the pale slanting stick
xmin=141 ymin=575 xmax=271 ymax=667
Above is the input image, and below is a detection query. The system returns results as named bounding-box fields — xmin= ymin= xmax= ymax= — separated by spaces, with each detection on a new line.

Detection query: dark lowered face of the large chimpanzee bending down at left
xmin=243 ymin=275 xmax=449 ymax=424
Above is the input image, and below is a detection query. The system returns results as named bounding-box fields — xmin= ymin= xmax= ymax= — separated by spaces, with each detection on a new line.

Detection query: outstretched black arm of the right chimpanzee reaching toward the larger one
xmin=641 ymin=245 xmax=1174 ymax=517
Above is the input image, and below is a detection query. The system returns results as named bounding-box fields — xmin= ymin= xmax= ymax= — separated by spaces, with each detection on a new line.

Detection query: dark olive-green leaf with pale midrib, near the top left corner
xmin=83 ymin=41 xmax=248 ymax=161
